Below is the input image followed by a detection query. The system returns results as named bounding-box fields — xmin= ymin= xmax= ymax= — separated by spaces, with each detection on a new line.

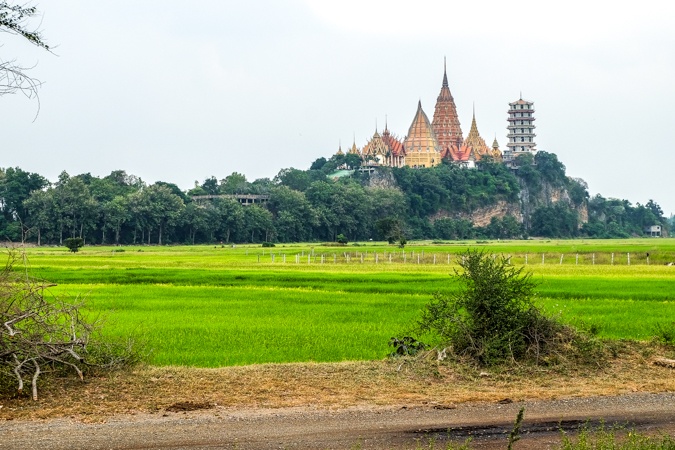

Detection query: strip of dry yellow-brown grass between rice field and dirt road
xmin=0 ymin=343 xmax=675 ymax=422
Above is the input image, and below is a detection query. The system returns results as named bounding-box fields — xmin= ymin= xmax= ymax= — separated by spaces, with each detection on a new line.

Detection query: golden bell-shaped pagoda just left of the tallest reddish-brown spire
xmin=403 ymin=101 xmax=441 ymax=167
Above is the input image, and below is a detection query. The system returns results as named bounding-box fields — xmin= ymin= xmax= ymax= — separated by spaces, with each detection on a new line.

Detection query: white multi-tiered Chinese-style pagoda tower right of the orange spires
xmin=504 ymin=96 xmax=537 ymax=165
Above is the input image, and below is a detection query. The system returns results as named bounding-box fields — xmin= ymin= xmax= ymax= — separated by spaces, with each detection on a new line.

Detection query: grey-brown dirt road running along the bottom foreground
xmin=0 ymin=393 xmax=675 ymax=450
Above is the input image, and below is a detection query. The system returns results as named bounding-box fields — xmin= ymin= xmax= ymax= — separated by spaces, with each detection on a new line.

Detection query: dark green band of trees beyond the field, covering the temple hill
xmin=0 ymin=152 xmax=668 ymax=245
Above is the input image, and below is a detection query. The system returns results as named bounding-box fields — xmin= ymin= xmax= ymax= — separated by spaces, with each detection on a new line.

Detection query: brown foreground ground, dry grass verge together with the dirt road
xmin=0 ymin=346 xmax=675 ymax=449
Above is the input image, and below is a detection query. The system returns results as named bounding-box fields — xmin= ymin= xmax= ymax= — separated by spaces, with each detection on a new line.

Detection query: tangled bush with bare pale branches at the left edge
xmin=0 ymin=251 xmax=137 ymax=400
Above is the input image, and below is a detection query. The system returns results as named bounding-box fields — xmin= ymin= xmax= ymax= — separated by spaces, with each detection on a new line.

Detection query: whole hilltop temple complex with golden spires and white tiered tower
xmin=337 ymin=62 xmax=537 ymax=170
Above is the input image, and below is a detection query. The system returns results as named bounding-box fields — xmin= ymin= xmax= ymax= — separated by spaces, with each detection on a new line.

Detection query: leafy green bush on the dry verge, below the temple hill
xmin=418 ymin=250 xmax=600 ymax=365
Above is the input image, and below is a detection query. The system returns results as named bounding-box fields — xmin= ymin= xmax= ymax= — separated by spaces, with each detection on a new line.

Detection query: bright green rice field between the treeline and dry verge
xmin=13 ymin=238 xmax=675 ymax=367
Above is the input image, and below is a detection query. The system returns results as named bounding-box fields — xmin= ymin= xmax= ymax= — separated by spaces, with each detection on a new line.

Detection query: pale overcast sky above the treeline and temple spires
xmin=0 ymin=0 xmax=675 ymax=217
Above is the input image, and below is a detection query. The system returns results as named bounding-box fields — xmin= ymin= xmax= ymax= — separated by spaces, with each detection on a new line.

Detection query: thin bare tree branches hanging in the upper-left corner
xmin=0 ymin=1 xmax=49 ymax=98
